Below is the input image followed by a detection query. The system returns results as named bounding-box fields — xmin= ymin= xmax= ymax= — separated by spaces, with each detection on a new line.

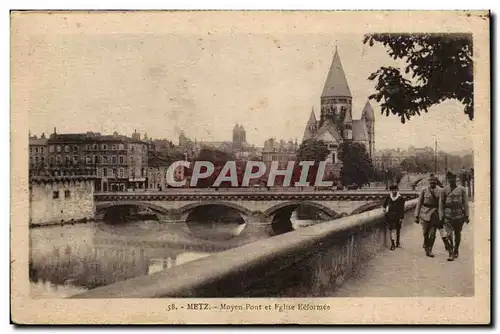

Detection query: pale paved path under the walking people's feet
xmin=331 ymin=203 xmax=474 ymax=297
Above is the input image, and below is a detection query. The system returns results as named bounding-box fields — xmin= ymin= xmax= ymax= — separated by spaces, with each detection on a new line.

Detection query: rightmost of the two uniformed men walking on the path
xmin=443 ymin=174 xmax=469 ymax=258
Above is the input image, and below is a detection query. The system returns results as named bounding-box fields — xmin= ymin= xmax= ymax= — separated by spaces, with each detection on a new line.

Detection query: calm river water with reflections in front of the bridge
xmin=29 ymin=215 xmax=324 ymax=298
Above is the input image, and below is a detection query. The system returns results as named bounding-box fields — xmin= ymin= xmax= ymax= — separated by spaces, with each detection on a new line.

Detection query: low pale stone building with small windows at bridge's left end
xmin=29 ymin=175 xmax=95 ymax=225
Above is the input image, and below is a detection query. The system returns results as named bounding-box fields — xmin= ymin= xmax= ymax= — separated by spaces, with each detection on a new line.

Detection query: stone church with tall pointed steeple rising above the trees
xmin=303 ymin=48 xmax=375 ymax=164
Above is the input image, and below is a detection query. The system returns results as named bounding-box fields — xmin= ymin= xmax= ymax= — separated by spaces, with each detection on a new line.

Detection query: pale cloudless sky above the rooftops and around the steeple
xmin=17 ymin=27 xmax=473 ymax=151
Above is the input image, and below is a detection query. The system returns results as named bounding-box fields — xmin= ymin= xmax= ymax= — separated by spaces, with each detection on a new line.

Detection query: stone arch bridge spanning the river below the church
xmin=95 ymin=191 xmax=417 ymax=224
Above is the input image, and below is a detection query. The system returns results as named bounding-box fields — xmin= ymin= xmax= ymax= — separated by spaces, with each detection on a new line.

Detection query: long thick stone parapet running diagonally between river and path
xmin=73 ymin=200 xmax=416 ymax=298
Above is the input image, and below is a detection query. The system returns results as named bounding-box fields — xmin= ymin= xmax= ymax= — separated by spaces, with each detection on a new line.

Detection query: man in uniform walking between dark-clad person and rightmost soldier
xmin=415 ymin=175 xmax=453 ymax=261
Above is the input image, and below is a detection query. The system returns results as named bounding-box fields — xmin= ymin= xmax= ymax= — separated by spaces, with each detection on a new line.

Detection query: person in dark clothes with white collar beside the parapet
xmin=383 ymin=185 xmax=405 ymax=250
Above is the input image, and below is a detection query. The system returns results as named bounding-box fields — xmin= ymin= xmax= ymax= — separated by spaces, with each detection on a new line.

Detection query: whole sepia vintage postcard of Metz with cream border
xmin=11 ymin=11 xmax=491 ymax=324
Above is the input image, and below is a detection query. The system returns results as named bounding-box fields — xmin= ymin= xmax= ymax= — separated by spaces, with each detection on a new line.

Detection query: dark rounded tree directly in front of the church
xmin=339 ymin=141 xmax=374 ymax=185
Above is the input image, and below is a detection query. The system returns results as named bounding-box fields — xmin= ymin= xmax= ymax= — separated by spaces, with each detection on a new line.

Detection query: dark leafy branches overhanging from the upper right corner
xmin=363 ymin=34 xmax=474 ymax=123
